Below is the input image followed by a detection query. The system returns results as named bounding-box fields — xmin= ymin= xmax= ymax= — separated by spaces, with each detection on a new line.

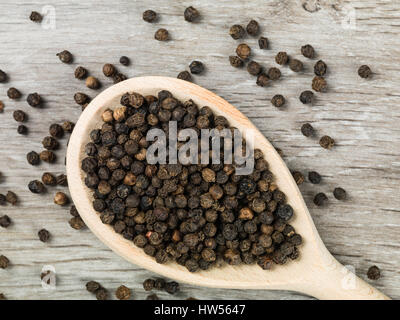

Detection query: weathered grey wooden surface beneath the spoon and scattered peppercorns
xmin=0 ymin=0 xmax=400 ymax=299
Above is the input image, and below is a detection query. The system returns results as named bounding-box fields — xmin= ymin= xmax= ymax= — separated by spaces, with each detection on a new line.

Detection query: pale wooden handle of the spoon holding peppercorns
xmin=301 ymin=256 xmax=390 ymax=300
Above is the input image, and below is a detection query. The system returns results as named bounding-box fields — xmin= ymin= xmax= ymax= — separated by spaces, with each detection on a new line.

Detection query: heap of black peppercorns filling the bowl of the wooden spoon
xmin=82 ymin=90 xmax=302 ymax=272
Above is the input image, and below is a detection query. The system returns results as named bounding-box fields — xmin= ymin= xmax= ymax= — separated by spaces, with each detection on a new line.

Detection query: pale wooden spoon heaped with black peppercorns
xmin=67 ymin=77 xmax=389 ymax=299
